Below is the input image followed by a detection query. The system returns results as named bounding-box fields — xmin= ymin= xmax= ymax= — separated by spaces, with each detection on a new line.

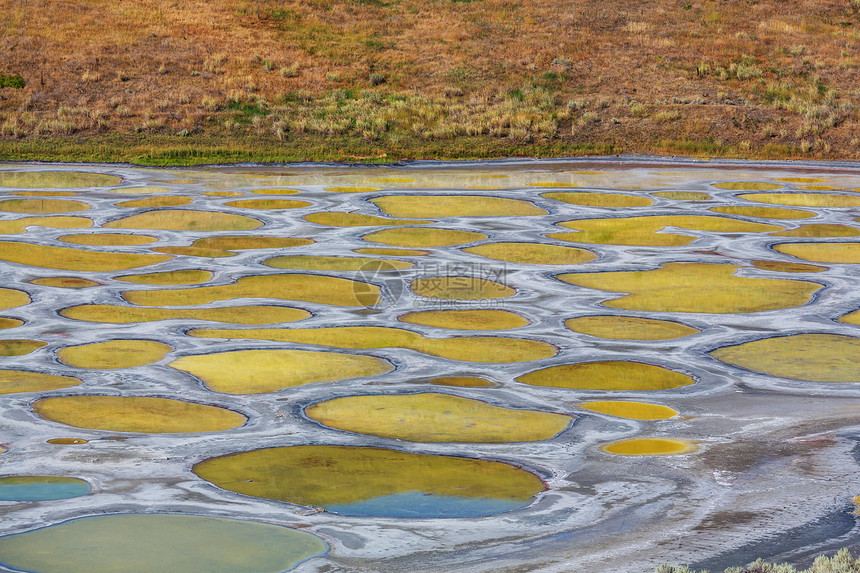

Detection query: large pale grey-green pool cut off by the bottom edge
xmin=0 ymin=514 xmax=328 ymax=573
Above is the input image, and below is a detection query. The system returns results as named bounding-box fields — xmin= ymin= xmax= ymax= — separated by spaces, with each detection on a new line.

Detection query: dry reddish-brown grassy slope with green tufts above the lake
xmin=0 ymin=0 xmax=860 ymax=164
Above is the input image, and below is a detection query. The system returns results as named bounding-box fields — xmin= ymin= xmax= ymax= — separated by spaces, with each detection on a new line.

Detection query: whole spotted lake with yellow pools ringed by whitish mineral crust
xmin=0 ymin=158 xmax=860 ymax=573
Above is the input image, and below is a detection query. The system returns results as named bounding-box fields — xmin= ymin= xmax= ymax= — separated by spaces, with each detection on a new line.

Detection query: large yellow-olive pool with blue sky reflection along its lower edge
xmin=193 ymin=446 xmax=545 ymax=517
